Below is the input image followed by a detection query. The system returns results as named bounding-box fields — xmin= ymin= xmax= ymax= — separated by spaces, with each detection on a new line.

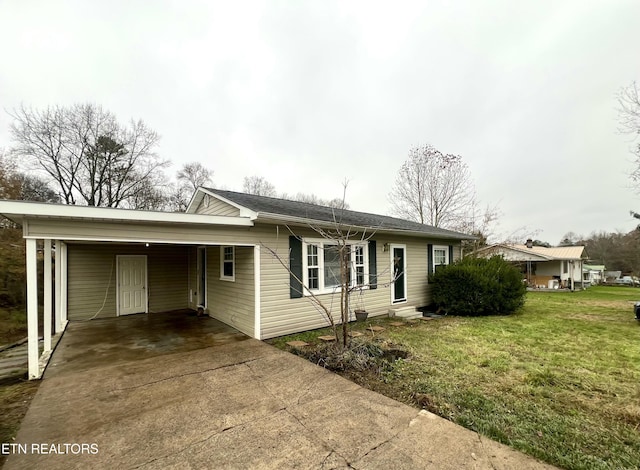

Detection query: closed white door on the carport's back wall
xmin=118 ymin=255 xmax=147 ymax=315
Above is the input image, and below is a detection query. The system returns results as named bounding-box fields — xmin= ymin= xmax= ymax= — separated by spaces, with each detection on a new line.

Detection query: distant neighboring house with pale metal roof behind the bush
xmin=475 ymin=240 xmax=587 ymax=289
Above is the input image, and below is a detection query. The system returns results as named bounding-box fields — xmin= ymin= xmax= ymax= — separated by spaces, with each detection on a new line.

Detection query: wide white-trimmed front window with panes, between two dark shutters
xmin=302 ymin=239 xmax=369 ymax=295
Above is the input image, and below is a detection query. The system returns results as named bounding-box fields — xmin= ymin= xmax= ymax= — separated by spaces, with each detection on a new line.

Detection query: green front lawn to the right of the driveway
xmin=273 ymin=287 xmax=640 ymax=469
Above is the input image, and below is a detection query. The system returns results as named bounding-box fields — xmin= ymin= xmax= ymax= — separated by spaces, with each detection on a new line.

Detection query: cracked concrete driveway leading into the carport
xmin=5 ymin=314 xmax=552 ymax=469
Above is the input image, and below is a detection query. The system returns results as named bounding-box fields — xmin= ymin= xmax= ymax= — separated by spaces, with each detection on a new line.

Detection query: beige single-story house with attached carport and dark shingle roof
xmin=0 ymin=188 xmax=473 ymax=378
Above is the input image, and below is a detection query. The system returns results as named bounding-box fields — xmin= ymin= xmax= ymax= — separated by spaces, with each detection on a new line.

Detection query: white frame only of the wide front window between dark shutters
xmin=302 ymin=238 xmax=369 ymax=296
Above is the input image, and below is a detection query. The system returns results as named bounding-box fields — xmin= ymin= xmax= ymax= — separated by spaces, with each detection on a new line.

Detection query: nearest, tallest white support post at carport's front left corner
xmin=26 ymin=238 xmax=40 ymax=379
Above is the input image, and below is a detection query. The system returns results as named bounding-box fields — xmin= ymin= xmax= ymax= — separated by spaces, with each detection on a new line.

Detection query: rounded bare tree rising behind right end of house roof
xmin=389 ymin=145 xmax=475 ymax=228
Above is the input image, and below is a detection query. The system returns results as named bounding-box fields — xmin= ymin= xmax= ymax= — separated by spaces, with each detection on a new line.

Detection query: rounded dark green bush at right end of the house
xmin=430 ymin=256 xmax=526 ymax=315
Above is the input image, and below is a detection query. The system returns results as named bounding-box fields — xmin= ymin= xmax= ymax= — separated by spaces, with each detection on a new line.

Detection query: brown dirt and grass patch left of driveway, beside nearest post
xmin=0 ymin=376 xmax=40 ymax=467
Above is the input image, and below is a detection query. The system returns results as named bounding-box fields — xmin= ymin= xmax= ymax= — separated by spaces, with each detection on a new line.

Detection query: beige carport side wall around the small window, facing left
xmin=206 ymin=246 xmax=255 ymax=336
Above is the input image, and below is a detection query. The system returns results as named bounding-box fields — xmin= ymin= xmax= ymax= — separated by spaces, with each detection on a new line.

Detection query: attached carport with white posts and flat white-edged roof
xmin=0 ymin=201 xmax=260 ymax=379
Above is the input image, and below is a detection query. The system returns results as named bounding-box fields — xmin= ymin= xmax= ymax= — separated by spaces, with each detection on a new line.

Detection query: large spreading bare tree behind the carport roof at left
xmin=9 ymin=104 xmax=169 ymax=208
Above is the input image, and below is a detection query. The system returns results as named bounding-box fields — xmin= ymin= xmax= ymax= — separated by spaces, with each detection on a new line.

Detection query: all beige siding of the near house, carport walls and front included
xmin=45 ymin=220 xmax=460 ymax=339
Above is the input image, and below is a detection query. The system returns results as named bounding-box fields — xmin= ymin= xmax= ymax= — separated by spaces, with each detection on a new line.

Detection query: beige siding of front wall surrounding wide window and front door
xmin=255 ymin=225 xmax=460 ymax=339
